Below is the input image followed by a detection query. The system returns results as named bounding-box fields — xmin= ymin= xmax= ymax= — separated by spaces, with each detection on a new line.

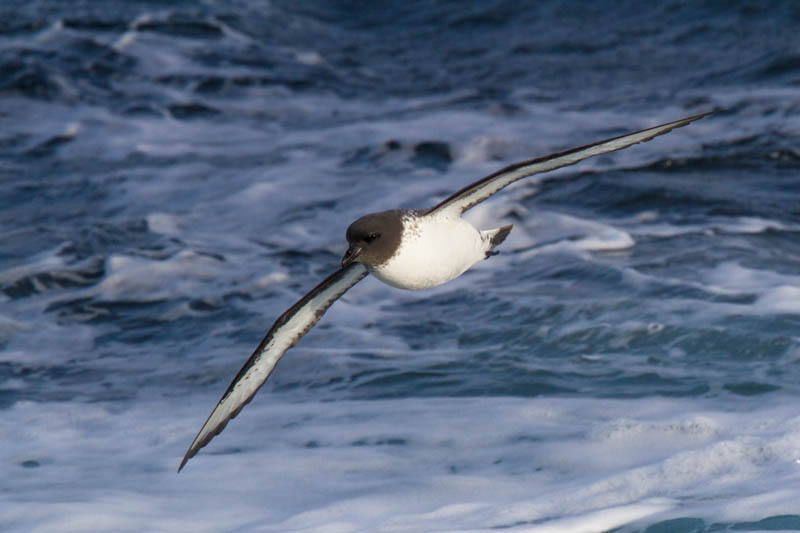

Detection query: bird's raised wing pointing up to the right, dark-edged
xmin=426 ymin=112 xmax=711 ymax=215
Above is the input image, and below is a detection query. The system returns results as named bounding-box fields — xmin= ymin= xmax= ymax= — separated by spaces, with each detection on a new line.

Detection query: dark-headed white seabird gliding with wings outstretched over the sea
xmin=178 ymin=112 xmax=711 ymax=472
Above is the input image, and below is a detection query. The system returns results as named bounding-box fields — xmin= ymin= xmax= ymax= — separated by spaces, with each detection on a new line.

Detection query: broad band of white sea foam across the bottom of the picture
xmin=0 ymin=394 xmax=800 ymax=532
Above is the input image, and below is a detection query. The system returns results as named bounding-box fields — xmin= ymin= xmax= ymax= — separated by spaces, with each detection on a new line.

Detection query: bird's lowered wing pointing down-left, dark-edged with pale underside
xmin=178 ymin=263 xmax=367 ymax=472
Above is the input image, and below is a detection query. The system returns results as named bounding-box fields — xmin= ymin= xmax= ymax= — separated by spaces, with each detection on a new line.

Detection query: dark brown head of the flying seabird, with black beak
xmin=342 ymin=209 xmax=407 ymax=266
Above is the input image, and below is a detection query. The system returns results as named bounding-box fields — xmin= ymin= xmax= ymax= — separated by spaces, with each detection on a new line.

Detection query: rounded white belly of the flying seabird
xmin=371 ymin=212 xmax=488 ymax=289
